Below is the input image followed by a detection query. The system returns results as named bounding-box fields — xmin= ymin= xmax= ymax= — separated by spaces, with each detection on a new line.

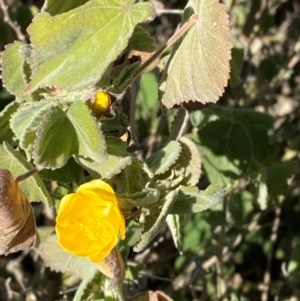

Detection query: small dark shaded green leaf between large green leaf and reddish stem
xmin=128 ymin=26 xmax=156 ymax=52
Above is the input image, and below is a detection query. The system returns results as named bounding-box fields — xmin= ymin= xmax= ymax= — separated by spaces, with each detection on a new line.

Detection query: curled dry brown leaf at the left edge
xmin=0 ymin=169 xmax=37 ymax=255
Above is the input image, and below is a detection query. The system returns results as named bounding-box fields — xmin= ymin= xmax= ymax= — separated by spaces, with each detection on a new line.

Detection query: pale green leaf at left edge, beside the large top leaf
xmin=2 ymin=42 xmax=29 ymax=99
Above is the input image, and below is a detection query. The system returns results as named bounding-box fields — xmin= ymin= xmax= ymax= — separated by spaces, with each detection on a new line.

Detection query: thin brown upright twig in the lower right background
xmin=261 ymin=207 xmax=281 ymax=301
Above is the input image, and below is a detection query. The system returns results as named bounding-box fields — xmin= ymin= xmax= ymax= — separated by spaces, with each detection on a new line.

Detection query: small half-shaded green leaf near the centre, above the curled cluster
xmin=146 ymin=141 xmax=182 ymax=174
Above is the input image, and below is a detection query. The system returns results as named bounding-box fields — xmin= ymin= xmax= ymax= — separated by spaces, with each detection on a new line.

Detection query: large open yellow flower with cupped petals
xmin=56 ymin=180 xmax=125 ymax=263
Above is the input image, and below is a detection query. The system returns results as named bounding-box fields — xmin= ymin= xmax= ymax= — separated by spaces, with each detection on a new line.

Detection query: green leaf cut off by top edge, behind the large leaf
xmin=42 ymin=0 xmax=89 ymax=16
